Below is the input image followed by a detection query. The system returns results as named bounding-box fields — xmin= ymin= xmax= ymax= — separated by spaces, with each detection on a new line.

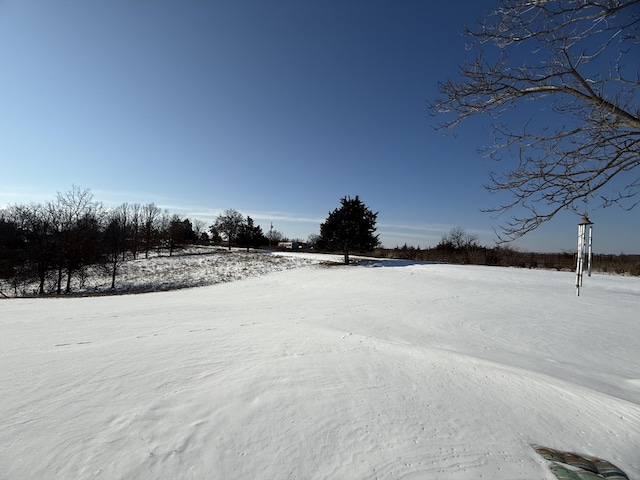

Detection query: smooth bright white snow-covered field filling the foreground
xmin=0 ymin=255 xmax=640 ymax=480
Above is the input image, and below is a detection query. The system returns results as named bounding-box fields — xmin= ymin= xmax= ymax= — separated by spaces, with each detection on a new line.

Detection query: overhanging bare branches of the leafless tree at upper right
xmin=430 ymin=0 xmax=640 ymax=241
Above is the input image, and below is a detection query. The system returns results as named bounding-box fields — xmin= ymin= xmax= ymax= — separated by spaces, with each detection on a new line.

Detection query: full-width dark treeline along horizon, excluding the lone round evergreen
xmin=0 ymin=186 xmax=640 ymax=296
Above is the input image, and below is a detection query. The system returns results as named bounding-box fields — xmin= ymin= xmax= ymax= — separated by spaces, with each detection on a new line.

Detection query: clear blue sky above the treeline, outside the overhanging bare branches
xmin=0 ymin=0 xmax=640 ymax=253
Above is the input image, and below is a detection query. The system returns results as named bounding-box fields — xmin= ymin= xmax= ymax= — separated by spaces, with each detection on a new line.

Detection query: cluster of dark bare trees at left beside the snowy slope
xmin=0 ymin=186 xmax=200 ymax=295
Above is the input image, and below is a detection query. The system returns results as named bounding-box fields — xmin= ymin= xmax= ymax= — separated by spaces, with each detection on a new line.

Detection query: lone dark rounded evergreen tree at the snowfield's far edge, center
xmin=319 ymin=195 xmax=380 ymax=265
